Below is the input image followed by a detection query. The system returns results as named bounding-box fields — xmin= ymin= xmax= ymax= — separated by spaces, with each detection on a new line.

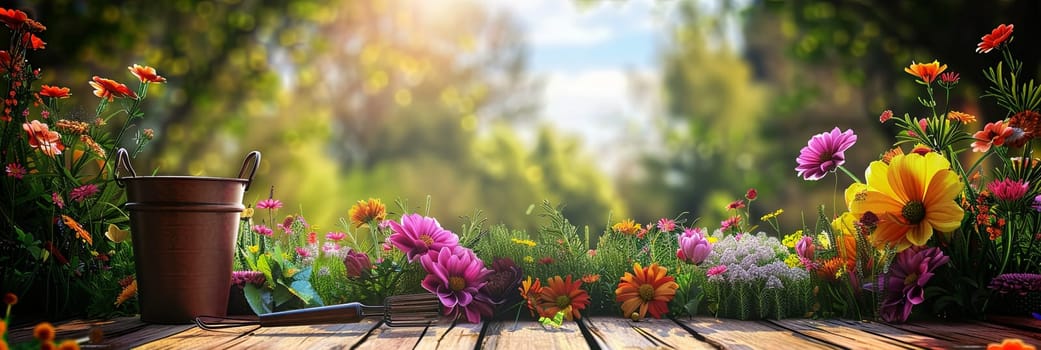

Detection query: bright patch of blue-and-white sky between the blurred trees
xmin=489 ymin=0 xmax=736 ymax=173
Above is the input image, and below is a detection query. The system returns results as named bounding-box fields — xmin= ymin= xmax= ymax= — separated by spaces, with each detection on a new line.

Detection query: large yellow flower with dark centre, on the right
xmin=846 ymin=152 xmax=964 ymax=251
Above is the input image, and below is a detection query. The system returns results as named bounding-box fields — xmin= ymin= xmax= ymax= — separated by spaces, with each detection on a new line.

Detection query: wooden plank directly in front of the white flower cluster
xmin=677 ymin=318 xmax=838 ymax=349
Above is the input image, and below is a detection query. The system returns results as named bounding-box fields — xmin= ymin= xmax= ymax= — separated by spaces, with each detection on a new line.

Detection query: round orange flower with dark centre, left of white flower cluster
xmin=614 ymin=263 xmax=680 ymax=319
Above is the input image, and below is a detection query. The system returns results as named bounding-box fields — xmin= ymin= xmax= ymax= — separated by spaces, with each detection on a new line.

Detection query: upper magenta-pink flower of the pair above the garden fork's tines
xmin=389 ymin=214 xmax=459 ymax=261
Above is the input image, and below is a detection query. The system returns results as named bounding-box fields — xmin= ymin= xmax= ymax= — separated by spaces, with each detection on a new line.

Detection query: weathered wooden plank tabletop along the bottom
xmin=9 ymin=317 xmax=1041 ymax=350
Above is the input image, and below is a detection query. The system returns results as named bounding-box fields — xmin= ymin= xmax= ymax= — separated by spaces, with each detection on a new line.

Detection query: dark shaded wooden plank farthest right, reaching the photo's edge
xmin=891 ymin=321 xmax=1041 ymax=347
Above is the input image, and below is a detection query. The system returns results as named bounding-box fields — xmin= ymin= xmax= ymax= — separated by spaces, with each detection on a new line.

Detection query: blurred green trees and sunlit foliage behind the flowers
xmin=18 ymin=0 xmax=1041 ymax=232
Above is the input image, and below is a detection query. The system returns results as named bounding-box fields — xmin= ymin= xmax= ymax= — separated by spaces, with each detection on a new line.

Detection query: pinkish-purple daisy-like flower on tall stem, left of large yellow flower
xmin=795 ymin=127 xmax=857 ymax=180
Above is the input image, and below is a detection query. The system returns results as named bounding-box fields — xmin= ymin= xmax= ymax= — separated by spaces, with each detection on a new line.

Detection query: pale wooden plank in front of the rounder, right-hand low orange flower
xmin=582 ymin=317 xmax=715 ymax=349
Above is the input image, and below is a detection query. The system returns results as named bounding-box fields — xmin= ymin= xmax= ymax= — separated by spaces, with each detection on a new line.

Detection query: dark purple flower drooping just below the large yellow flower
xmin=880 ymin=246 xmax=950 ymax=322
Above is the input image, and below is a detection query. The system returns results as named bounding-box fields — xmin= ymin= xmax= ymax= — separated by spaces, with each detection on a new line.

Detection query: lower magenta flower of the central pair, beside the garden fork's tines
xmin=420 ymin=247 xmax=492 ymax=323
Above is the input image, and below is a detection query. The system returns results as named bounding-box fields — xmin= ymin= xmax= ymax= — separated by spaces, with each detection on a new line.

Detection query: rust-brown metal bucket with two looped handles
xmin=117 ymin=149 xmax=260 ymax=324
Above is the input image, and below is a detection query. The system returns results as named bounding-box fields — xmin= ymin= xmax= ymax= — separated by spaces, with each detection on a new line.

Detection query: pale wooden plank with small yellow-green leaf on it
xmin=481 ymin=321 xmax=590 ymax=350
